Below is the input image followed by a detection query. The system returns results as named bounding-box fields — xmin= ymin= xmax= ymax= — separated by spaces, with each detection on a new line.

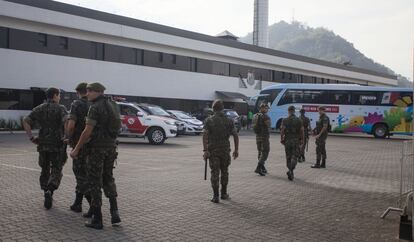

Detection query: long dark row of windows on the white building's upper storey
xmin=0 ymin=27 xmax=347 ymax=83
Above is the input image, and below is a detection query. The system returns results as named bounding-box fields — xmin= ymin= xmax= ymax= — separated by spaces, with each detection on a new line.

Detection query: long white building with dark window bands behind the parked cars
xmin=0 ymin=0 xmax=397 ymax=118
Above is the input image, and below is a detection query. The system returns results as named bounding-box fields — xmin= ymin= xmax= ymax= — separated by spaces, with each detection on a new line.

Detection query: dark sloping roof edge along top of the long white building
xmin=5 ymin=0 xmax=397 ymax=80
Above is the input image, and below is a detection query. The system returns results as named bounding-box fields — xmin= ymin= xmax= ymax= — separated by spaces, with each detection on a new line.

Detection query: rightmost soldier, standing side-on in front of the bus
xmin=311 ymin=107 xmax=329 ymax=168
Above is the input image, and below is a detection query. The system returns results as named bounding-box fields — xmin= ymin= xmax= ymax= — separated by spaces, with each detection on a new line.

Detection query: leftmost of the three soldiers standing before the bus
xmin=253 ymin=103 xmax=270 ymax=176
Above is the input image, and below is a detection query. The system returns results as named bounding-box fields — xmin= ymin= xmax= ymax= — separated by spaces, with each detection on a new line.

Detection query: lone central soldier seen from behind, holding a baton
xmin=203 ymin=100 xmax=239 ymax=203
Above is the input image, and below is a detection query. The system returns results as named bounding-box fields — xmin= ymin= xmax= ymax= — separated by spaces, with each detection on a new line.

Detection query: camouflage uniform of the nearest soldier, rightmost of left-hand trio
xmin=86 ymin=95 xmax=119 ymax=209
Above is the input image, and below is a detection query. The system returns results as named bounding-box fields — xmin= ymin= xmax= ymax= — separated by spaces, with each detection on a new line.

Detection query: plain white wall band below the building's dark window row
xmin=0 ymin=49 xmax=274 ymax=101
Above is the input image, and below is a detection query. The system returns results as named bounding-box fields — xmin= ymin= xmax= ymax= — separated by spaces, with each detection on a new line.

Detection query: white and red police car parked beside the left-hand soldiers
xmin=116 ymin=102 xmax=177 ymax=145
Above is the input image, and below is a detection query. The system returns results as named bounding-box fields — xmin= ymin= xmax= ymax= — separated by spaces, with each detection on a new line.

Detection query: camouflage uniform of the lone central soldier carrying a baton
xmin=204 ymin=112 xmax=236 ymax=193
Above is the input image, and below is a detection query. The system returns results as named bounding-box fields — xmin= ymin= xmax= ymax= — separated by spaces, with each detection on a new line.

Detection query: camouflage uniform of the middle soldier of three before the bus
xmin=282 ymin=114 xmax=302 ymax=171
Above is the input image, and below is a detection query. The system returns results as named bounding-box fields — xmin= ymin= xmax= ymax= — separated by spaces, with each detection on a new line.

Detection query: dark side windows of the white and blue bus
xmin=276 ymin=90 xmax=413 ymax=106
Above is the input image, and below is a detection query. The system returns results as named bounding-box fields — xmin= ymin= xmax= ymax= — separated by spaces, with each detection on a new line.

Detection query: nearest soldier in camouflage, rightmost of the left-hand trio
xmin=70 ymin=82 xmax=121 ymax=229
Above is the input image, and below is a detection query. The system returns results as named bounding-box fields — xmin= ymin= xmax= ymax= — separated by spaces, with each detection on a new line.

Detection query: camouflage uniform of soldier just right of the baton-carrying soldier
xmin=254 ymin=113 xmax=270 ymax=168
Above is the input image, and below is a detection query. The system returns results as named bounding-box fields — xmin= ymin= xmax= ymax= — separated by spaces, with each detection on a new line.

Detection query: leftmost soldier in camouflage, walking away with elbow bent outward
xmin=23 ymin=87 xmax=67 ymax=209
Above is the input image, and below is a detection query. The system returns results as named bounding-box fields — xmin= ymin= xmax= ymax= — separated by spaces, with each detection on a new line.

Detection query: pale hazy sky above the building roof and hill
xmin=58 ymin=0 xmax=414 ymax=80
